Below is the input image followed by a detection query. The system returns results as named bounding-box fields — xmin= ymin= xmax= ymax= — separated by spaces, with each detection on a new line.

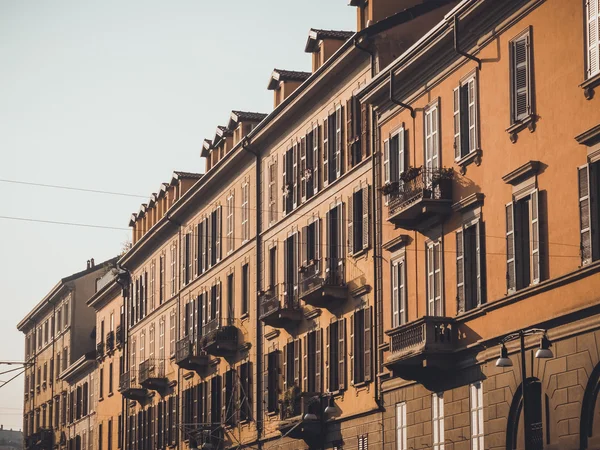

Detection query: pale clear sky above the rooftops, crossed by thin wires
xmin=0 ymin=0 xmax=356 ymax=429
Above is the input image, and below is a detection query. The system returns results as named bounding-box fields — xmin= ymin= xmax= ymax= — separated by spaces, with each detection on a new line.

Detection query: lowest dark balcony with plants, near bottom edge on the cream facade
xmin=277 ymin=388 xmax=324 ymax=443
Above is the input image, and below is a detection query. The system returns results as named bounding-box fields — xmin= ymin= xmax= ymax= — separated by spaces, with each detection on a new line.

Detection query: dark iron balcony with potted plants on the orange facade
xmin=382 ymin=167 xmax=454 ymax=231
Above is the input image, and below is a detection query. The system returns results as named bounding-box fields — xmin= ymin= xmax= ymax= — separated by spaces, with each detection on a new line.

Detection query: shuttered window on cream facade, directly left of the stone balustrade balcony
xmin=350 ymin=307 xmax=373 ymax=385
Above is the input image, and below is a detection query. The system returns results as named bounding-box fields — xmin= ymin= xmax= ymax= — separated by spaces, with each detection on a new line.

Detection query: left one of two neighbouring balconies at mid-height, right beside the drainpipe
xmin=259 ymin=283 xmax=302 ymax=328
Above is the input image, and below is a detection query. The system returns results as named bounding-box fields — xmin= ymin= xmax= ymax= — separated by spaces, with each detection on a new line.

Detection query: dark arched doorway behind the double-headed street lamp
xmin=506 ymin=378 xmax=544 ymax=450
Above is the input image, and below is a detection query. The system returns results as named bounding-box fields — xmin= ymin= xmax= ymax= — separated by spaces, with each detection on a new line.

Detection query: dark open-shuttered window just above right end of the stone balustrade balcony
xmin=456 ymin=220 xmax=485 ymax=313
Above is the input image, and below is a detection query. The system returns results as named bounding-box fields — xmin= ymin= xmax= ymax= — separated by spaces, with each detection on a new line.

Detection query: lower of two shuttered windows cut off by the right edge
xmin=578 ymin=161 xmax=600 ymax=264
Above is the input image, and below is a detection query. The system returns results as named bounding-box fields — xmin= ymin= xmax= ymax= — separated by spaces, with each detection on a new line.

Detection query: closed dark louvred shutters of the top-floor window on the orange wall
xmin=512 ymin=34 xmax=531 ymax=122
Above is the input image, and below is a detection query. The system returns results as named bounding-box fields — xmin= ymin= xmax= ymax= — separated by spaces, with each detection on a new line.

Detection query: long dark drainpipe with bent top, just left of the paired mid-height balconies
xmin=242 ymin=136 xmax=264 ymax=450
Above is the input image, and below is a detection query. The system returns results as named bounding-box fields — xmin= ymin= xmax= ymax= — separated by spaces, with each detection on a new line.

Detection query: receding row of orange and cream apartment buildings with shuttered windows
xmin=19 ymin=0 xmax=600 ymax=450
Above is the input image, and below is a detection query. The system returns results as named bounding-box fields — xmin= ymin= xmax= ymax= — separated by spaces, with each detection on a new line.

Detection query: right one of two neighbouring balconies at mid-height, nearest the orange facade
xmin=300 ymin=258 xmax=348 ymax=308
